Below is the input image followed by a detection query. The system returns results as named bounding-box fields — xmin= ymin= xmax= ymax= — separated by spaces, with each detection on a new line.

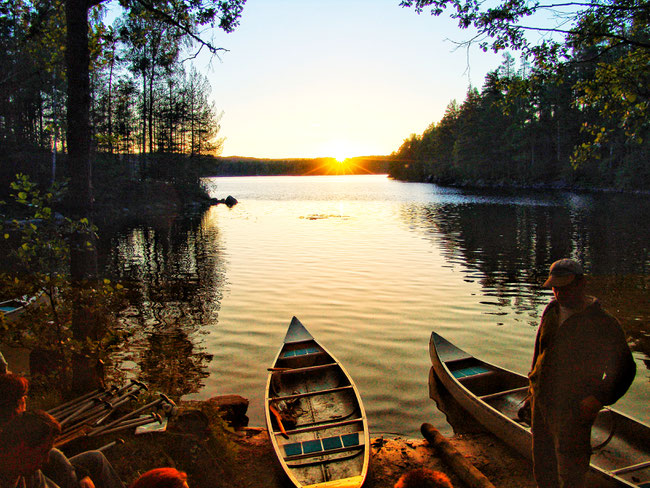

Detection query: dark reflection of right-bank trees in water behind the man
xmin=403 ymin=194 xmax=650 ymax=354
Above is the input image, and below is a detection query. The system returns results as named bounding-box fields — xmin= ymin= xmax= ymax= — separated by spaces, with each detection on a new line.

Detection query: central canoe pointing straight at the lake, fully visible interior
xmin=265 ymin=317 xmax=370 ymax=488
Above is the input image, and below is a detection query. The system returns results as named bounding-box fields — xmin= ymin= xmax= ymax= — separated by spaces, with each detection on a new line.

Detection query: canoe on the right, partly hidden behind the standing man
xmin=429 ymin=332 xmax=650 ymax=488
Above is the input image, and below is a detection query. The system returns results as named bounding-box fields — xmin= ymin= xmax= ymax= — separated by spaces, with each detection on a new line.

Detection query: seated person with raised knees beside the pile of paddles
xmin=0 ymin=411 xmax=124 ymax=488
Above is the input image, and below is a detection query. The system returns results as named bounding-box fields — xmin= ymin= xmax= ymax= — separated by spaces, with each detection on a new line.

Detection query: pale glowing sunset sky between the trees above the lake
xmin=201 ymin=0 xmax=502 ymax=158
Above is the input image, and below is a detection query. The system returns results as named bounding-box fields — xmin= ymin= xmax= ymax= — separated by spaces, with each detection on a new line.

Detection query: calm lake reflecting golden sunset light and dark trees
xmin=102 ymin=175 xmax=650 ymax=436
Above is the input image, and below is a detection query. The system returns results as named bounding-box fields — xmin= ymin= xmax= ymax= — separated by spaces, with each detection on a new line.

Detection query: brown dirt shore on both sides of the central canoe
xmin=95 ymin=414 xmax=536 ymax=488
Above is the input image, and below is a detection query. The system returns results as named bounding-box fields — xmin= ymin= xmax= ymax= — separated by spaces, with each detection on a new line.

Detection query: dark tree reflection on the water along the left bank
xmin=98 ymin=211 xmax=224 ymax=396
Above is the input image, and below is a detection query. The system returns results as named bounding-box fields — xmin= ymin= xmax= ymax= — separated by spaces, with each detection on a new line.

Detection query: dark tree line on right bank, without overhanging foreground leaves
xmin=390 ymin=54 xmax=650 ymax=190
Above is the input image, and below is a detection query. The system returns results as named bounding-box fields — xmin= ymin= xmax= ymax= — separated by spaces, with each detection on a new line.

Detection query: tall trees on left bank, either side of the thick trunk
xmin=0 ymin=0 xmax=223 ymax=187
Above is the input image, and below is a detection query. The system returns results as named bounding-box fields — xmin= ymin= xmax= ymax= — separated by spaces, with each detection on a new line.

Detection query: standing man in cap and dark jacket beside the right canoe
xmin=528 ymin=259 xmax=636 ymax=488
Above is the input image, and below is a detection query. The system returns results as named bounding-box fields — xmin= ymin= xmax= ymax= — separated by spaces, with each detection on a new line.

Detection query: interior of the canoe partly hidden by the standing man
xmin=431 ymin=334 xmax=650 ymax=487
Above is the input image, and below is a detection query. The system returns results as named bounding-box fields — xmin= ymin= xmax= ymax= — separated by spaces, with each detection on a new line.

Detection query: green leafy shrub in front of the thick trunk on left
xmin=0 ymin=174 xmax=124 ymax=389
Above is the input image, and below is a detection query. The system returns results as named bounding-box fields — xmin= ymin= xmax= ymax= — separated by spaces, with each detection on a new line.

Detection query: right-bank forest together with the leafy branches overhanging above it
xmin=390 ymin=0 xmax=650 ymax=191
